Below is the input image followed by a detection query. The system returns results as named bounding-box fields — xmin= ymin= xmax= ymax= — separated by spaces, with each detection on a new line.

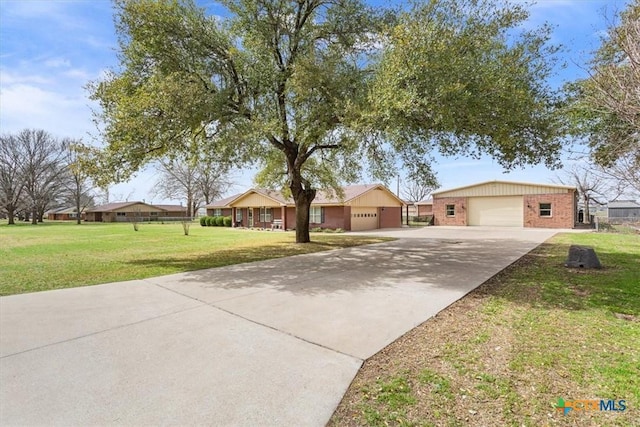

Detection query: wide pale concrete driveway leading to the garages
xmin=0 ymin=227 xmax=557 ymax=426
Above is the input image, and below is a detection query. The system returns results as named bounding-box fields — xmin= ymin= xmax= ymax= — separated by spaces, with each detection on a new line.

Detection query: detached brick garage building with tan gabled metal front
xmin=432 ymin=181 xmax=577 ymax=228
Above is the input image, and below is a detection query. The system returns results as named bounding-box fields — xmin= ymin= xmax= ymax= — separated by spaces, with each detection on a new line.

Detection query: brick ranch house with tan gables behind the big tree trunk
xmin=207 ymin=184 xmax=403 ymax=231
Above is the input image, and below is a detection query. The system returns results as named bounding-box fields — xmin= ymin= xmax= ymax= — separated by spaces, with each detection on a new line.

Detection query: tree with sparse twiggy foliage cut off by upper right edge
xmin=568 ymin=0 xmax=640 ymax=168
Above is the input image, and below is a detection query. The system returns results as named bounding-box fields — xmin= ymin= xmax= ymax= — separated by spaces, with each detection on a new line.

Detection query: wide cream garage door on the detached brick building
xmin=468 ymin=196 xmax=524 ymax=227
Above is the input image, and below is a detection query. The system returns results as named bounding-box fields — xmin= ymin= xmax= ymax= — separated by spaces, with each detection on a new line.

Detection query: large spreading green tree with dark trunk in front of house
xmin=91 ymin=0 xmax=559 ymax=242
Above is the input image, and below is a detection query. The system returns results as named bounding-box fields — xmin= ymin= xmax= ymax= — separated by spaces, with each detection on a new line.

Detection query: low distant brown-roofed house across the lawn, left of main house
xmin=85 ymin=202 xmax=187 ymax=222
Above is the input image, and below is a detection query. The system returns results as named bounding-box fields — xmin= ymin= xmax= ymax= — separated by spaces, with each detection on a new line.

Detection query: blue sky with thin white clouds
xmin=0 ymin=0 xmax=628 ymax=202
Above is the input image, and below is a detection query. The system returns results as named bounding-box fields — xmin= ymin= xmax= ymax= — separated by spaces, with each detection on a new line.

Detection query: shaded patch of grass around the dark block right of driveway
xmin=477 ymin=243 xmax=640 ymax=321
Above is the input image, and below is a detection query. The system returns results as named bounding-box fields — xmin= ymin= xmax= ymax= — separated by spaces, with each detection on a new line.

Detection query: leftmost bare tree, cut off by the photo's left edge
xmin=0 ymin=134 xmax=25 ymax=224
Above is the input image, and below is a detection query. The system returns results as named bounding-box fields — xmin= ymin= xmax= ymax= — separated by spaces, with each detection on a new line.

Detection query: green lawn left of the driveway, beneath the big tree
xmin=0 ymin=222 xmax=384 ymax=295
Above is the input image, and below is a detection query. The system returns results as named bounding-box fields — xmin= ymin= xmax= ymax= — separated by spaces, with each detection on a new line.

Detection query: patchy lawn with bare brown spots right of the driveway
xmin=330 ymin=233 xmax=640 ymax=426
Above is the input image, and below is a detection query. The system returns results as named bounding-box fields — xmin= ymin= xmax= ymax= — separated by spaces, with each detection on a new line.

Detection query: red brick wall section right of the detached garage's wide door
xmin=524 ymin=192 xmax=575 ymax=228
